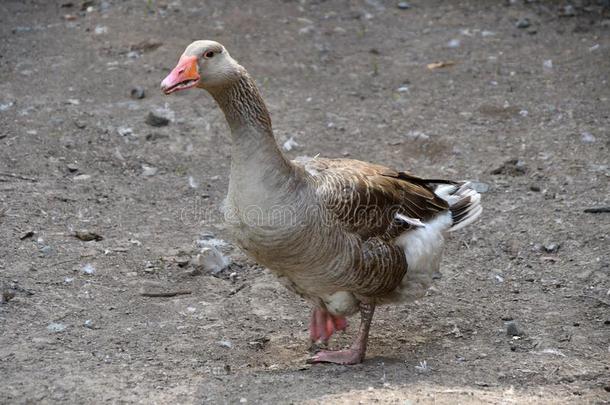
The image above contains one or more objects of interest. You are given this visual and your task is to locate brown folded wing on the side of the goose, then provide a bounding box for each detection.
[294,158,452,241]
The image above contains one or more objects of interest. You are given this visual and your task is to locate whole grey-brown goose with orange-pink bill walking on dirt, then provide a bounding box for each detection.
[161,40,482,364]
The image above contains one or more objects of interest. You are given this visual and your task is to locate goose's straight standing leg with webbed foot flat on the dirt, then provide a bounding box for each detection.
[307,304,375,364]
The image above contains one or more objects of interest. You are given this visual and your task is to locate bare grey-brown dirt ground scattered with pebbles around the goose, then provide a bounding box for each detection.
[0,0,610,404]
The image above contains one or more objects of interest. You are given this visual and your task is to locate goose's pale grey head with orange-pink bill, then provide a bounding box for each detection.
[161,41,243,94]
